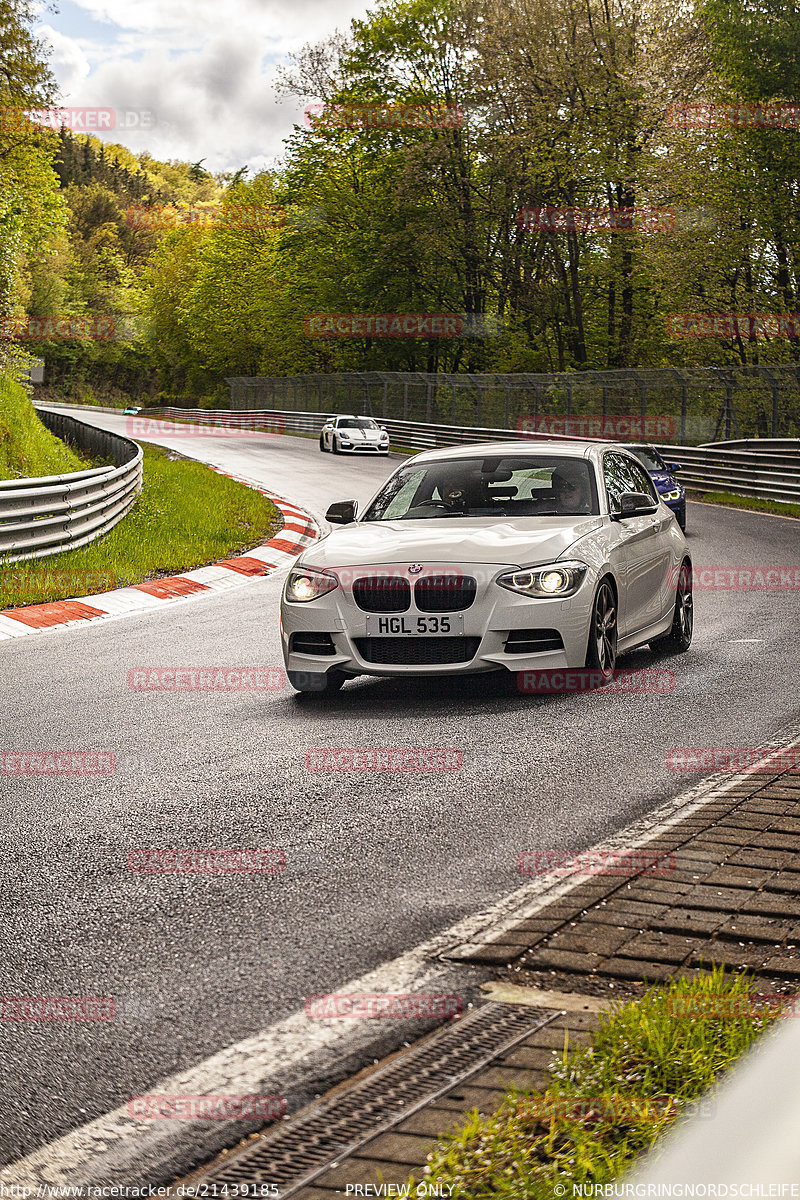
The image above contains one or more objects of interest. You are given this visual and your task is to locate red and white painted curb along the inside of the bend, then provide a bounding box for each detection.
[0,463,319,640]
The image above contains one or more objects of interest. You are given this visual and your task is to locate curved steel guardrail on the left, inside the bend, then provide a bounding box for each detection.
[0,409,142,563]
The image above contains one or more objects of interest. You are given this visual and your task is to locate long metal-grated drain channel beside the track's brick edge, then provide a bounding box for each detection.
[185,1002,560,1198]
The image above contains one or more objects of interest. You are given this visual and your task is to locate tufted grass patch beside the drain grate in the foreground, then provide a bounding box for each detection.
[409,968,776,1200]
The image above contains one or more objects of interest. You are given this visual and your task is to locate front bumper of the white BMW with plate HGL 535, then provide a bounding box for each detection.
[281,563,596,676]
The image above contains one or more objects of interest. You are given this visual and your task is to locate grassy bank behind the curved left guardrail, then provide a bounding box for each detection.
[0,374,94,479]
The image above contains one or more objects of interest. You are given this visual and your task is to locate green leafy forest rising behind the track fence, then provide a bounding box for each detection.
[0,0,800,402]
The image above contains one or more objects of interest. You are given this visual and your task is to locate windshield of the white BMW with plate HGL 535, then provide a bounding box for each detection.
[363,455,600,521]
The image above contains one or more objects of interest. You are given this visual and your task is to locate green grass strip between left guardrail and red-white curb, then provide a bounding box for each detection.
[0,445,283,608]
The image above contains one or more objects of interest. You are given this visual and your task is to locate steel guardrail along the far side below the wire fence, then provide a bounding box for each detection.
[143,408,800,504]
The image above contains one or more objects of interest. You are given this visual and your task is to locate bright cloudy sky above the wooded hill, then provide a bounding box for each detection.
[36,0,367,175]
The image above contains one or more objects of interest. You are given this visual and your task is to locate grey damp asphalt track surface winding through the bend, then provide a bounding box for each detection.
[0,414,800,1163]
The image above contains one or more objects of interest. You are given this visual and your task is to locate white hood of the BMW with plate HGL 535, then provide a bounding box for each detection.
[301,516,602,569]
